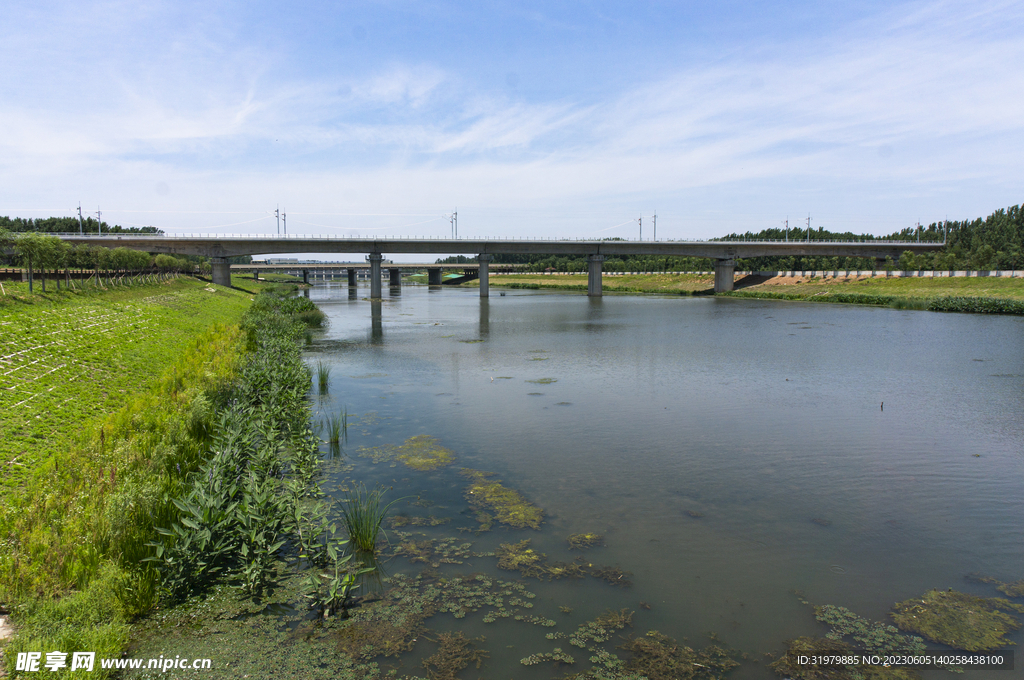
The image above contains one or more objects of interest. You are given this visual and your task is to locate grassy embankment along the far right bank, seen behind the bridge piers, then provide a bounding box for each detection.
[463,273,1024,314]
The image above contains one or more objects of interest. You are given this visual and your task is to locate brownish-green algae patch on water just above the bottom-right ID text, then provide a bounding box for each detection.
[892,589,1024,651]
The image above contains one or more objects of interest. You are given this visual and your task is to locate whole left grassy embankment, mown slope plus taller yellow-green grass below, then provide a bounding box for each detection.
[0,278,272,670]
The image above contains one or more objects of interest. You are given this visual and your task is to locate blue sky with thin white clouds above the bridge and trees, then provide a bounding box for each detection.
[0,0,1024,255]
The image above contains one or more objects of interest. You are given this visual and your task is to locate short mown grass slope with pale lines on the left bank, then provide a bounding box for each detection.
[0,279,256,487]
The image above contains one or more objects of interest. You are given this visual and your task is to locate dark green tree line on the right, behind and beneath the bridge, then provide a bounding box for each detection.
[437,205,1024,272]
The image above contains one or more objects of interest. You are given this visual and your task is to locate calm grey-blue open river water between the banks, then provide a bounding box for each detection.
[310,287,1024,678]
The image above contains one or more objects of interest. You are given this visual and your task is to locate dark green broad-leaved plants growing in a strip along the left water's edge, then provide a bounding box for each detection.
[148,294,366,615]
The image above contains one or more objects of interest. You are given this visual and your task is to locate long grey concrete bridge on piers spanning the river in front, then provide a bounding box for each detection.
[58,233,944,299]
